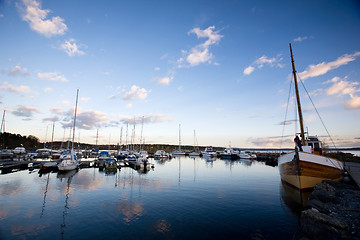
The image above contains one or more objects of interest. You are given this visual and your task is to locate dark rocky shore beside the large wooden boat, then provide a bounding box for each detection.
[294,181,360,240]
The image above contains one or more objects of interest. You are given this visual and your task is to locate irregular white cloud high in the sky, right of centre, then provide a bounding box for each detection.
[177,26,223,67]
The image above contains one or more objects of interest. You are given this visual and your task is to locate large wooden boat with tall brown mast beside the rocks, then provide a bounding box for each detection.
[278,44,344,191]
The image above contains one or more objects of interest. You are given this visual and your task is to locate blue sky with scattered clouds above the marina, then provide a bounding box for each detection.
[0,0,360,148]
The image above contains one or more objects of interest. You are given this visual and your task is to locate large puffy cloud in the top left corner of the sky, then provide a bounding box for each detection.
[22,0,67,37]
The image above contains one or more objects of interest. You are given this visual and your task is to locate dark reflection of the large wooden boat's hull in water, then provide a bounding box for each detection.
[280,182,311,216]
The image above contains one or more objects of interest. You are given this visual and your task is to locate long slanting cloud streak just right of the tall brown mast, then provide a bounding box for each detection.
[299,52,360,80]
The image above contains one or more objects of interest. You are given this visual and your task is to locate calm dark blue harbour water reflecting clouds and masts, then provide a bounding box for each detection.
[0,157,299,240]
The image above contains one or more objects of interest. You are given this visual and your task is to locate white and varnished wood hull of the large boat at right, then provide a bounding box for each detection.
[278,152,344,191]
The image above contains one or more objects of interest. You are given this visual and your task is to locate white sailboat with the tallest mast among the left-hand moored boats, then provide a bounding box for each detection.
[58,89,79,171]
